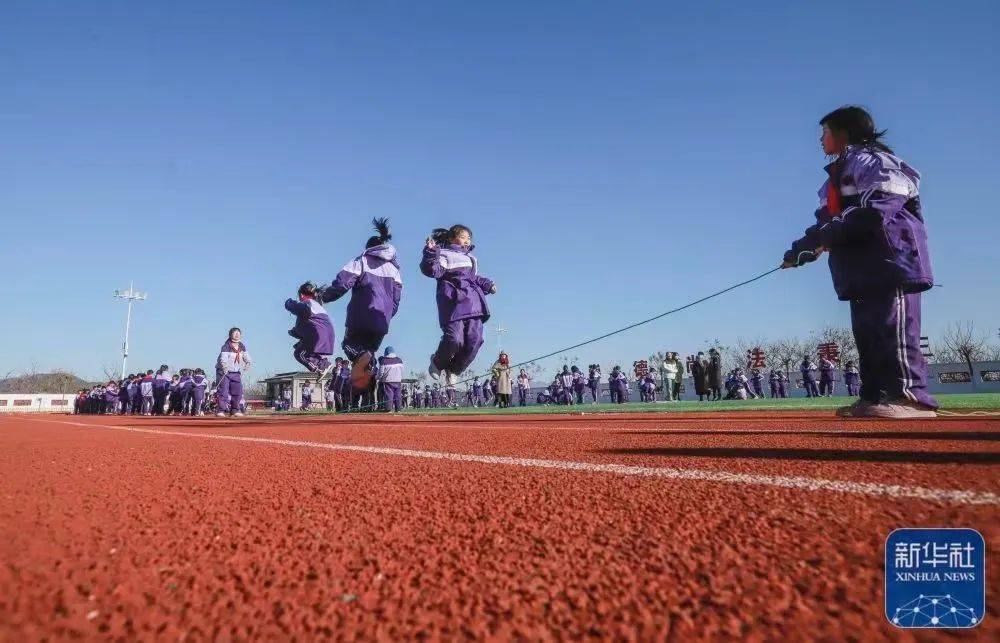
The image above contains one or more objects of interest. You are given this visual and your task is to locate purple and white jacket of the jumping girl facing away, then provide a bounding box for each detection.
[317,243,403,334]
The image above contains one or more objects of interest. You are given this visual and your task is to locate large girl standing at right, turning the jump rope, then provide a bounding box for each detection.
[781,106,938,418]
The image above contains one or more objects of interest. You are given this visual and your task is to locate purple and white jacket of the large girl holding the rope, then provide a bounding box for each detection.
[785,145,934,301]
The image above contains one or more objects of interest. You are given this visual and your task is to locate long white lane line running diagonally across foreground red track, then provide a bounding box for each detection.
[13,418,1000,505]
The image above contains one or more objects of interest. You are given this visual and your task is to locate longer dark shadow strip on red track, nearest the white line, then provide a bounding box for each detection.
[595,447,1000,464]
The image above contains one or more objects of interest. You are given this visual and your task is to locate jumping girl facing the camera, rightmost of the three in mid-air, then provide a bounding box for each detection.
[420,225,497,382]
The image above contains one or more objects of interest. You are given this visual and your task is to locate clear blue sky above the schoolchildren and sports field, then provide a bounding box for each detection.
[0,0,1000,377]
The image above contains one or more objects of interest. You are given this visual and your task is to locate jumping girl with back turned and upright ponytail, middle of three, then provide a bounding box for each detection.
[318,219,403,389]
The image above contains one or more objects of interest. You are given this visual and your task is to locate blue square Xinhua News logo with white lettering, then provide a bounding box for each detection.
[885,529,986,628]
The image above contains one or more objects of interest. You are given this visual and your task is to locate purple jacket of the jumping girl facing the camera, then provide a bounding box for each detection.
[420,243,493,328]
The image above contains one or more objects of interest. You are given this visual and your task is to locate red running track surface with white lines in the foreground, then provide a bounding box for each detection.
[0,413,1000,641]
